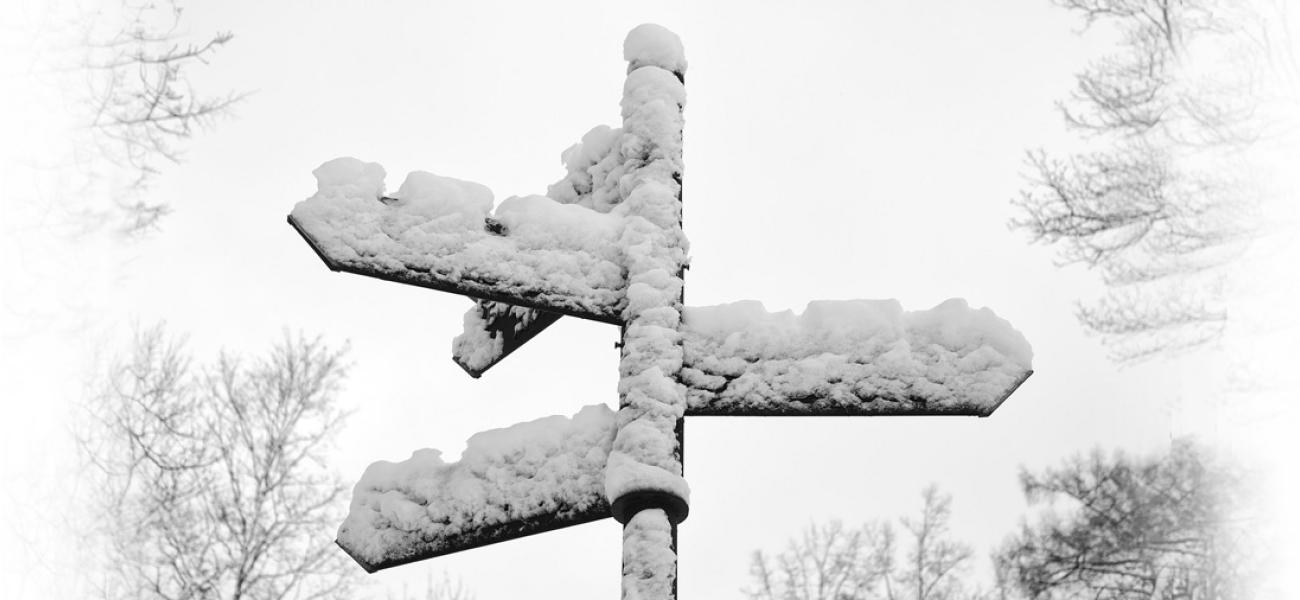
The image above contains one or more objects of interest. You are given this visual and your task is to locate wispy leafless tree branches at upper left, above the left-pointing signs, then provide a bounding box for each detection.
[35,0,244,235]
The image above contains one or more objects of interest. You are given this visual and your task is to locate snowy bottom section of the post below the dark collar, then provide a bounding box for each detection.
[623,508,677,600]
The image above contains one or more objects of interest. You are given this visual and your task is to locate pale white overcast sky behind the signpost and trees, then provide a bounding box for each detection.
[0,0,1294,600]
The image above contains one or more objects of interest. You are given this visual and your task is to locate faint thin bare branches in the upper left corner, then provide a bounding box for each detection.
[10,0,246,236]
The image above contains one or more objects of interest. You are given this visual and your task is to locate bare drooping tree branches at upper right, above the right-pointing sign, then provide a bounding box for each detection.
[1011,0,1300,361]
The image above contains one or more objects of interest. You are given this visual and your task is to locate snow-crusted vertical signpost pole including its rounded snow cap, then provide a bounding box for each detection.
[611,26,688,600]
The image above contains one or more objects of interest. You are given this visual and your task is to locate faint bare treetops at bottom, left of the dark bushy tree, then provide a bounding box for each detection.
[745,486,971,600]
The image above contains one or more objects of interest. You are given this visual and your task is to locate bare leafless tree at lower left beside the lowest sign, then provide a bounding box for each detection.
[79,327,359,600]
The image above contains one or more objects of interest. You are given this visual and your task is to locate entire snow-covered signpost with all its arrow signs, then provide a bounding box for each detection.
[289,25,1032,599]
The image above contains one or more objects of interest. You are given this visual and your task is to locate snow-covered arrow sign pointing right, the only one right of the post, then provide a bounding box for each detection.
[681,299,1032,416]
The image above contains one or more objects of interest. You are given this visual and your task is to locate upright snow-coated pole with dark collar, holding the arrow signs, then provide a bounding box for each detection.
[606,38,689,599]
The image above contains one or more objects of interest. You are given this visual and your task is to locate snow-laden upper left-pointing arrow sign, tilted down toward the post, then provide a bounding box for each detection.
[290,157,625,322]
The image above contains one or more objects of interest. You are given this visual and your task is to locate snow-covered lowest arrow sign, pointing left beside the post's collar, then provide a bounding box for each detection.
[338,404,615,571]
